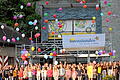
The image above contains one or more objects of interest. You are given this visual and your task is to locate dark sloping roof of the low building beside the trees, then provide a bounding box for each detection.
[0,23,30,44]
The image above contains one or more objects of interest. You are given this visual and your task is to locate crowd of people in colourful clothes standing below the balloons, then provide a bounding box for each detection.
[0,61,120,80]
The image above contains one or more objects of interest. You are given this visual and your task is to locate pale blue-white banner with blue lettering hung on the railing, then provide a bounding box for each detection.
[62,34,105,51]
